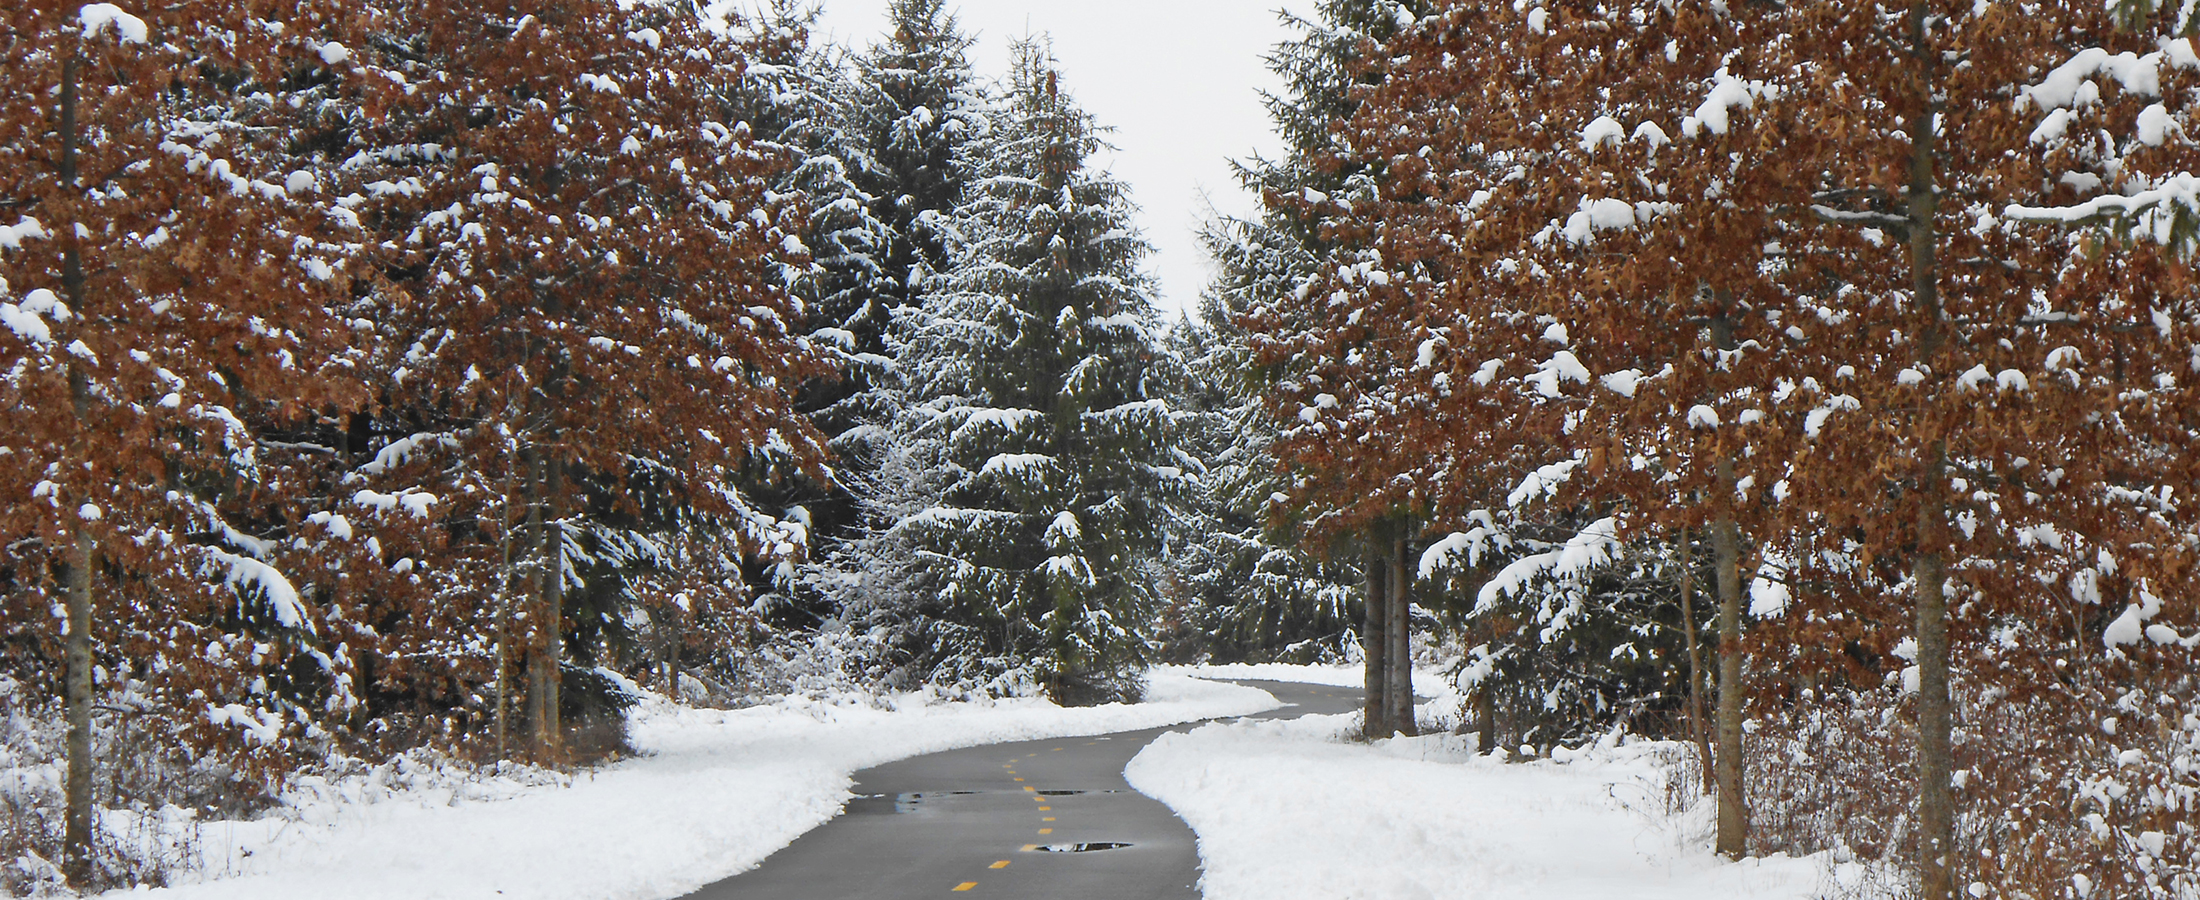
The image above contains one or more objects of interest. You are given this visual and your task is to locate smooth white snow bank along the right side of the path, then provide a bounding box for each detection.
[1126,715,1826,900]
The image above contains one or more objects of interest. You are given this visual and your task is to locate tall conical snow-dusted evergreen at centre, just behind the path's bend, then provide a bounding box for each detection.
[865,42,1186,704]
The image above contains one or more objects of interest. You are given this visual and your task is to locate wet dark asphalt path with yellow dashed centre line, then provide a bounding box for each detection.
[689,682,1360,900]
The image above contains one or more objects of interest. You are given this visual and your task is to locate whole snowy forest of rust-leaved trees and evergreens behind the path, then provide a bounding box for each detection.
[0,0,2200,900]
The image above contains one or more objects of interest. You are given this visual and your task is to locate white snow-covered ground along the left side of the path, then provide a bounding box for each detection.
[117,671,1276,900]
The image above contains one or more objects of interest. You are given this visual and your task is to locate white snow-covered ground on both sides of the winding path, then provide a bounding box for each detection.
[116,667,1828,900]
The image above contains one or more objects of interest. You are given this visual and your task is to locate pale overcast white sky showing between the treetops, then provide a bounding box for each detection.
[818,0,1311,317]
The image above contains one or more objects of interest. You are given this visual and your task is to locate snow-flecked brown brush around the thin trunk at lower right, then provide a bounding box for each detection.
[1745,658,2200,900]
